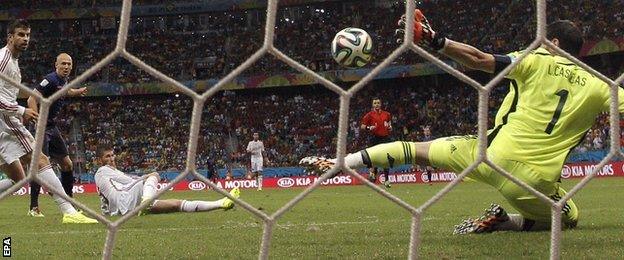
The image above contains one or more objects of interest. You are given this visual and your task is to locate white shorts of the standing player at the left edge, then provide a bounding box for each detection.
[0,115,35,165]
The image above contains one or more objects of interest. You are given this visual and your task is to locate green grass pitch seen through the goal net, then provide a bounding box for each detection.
[0,178,624,259]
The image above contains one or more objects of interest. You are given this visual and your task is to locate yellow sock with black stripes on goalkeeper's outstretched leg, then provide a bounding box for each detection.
[360,141,416,168]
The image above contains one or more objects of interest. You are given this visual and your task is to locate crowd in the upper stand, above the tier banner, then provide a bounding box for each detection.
[2,0,624,84]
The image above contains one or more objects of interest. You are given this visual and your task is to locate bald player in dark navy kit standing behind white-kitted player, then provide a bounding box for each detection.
[28,53,87,217]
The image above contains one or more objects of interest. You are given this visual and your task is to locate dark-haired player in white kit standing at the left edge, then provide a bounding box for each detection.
[0,19,97,223]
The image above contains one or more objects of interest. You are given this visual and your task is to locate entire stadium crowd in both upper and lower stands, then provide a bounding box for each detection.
[0,0,624,176]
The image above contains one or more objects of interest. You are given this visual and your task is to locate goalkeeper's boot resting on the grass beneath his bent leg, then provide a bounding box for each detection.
[453,203,509,235]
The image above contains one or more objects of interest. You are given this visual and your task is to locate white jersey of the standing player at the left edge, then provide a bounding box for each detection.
[0,46,25,117]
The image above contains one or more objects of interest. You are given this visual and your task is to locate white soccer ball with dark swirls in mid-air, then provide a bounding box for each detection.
[332,27,373,68]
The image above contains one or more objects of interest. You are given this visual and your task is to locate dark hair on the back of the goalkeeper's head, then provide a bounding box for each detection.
[546,20,583,56]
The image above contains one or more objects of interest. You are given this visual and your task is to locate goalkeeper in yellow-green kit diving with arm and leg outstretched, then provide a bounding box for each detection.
[301,10,624,234]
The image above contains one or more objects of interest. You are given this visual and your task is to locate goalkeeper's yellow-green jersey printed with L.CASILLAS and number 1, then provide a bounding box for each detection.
[488,48,624,181]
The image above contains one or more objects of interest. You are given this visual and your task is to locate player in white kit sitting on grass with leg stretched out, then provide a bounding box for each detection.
[95,144,240,215]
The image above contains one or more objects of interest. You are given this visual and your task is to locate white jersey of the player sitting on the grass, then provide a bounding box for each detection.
[95,165,144,215]
